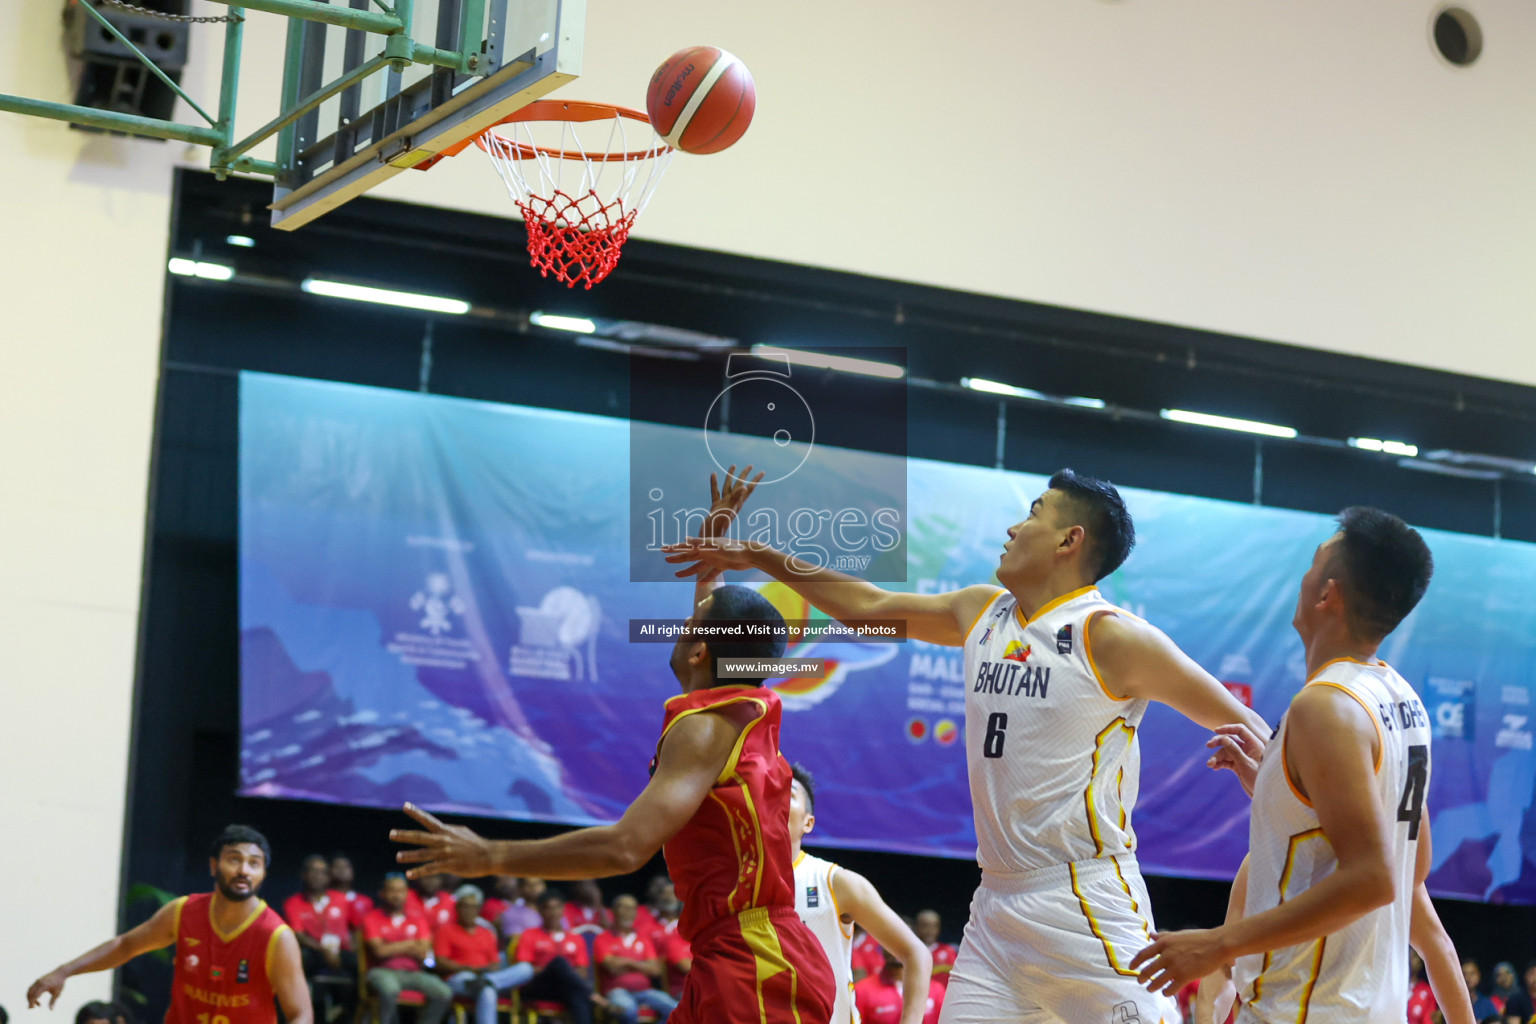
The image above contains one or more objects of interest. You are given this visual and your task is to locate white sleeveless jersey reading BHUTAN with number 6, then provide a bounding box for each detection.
[965,586,1147,877]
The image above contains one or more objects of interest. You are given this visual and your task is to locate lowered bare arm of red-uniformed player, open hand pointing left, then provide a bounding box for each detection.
[389,712,743,881]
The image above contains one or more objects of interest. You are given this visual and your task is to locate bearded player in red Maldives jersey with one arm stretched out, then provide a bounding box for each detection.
[26,824,315,1024]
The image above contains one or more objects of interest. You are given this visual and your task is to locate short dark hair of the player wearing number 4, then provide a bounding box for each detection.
[1332,505,1435,642]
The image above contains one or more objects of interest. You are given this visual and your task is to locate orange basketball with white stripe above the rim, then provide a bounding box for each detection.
[645,46,757,154]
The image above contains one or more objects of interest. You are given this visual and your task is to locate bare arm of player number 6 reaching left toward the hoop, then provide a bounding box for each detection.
[662,539,1001,646]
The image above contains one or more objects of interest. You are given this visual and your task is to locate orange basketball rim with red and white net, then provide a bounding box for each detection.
[422,100,674,289]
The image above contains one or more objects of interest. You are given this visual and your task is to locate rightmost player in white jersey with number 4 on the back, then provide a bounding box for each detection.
[1134,508,1473,1024]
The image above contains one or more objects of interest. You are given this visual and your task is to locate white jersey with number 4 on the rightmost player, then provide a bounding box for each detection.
[1235,659,1430,1024]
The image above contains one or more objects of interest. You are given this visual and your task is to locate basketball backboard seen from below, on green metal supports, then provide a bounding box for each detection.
[272,0,587,230]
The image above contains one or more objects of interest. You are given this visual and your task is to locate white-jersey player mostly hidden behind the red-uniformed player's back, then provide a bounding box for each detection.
[790,765,934,1024]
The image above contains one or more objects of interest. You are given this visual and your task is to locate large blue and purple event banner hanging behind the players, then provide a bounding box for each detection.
[240,373,1536,904]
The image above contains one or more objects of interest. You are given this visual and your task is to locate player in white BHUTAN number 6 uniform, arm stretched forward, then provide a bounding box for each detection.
[665,470,1269,1024]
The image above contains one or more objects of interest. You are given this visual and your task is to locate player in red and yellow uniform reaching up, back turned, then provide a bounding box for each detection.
[390,467,834,1024]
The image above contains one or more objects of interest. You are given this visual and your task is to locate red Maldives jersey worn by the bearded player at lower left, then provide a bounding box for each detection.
[166,892,292,1024]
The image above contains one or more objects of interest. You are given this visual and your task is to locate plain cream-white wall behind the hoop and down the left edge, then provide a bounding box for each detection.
[0,0,1536,1013]
